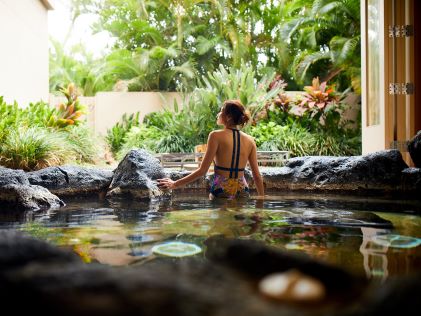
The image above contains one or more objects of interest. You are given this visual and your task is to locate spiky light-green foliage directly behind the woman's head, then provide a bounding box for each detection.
[115,65,281,157]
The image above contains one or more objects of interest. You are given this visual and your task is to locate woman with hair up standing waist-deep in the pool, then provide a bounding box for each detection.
[158,100,264,199]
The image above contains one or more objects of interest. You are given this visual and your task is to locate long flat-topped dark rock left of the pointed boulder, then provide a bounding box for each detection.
[27,166,113,196]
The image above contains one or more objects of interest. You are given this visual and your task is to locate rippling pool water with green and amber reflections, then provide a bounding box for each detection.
[0,193,421,279]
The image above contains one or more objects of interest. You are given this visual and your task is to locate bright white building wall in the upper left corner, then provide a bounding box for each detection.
[0,0,48,107]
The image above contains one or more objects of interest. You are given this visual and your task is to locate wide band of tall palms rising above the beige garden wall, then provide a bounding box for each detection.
[63,0,360,95]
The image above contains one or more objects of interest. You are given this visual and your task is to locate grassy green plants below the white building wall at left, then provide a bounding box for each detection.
[0,93,98,170]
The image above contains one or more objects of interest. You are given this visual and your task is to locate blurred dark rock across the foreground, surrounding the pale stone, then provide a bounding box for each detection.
[0,232,421,316]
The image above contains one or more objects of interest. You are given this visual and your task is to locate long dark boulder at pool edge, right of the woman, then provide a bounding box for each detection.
[264,150,408,192]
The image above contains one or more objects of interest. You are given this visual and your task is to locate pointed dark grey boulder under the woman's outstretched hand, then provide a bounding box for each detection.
[107,149,167,199]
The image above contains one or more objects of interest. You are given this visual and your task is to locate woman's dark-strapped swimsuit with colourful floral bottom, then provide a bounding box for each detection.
[210,129,249,199]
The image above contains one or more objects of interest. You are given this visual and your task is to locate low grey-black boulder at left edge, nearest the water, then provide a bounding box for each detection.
[0,184,65,211]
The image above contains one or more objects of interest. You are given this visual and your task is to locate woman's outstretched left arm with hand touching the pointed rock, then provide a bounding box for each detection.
[158,132,218,189]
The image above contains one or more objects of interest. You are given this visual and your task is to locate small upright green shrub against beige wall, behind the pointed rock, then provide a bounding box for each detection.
[105,112,140,155]
